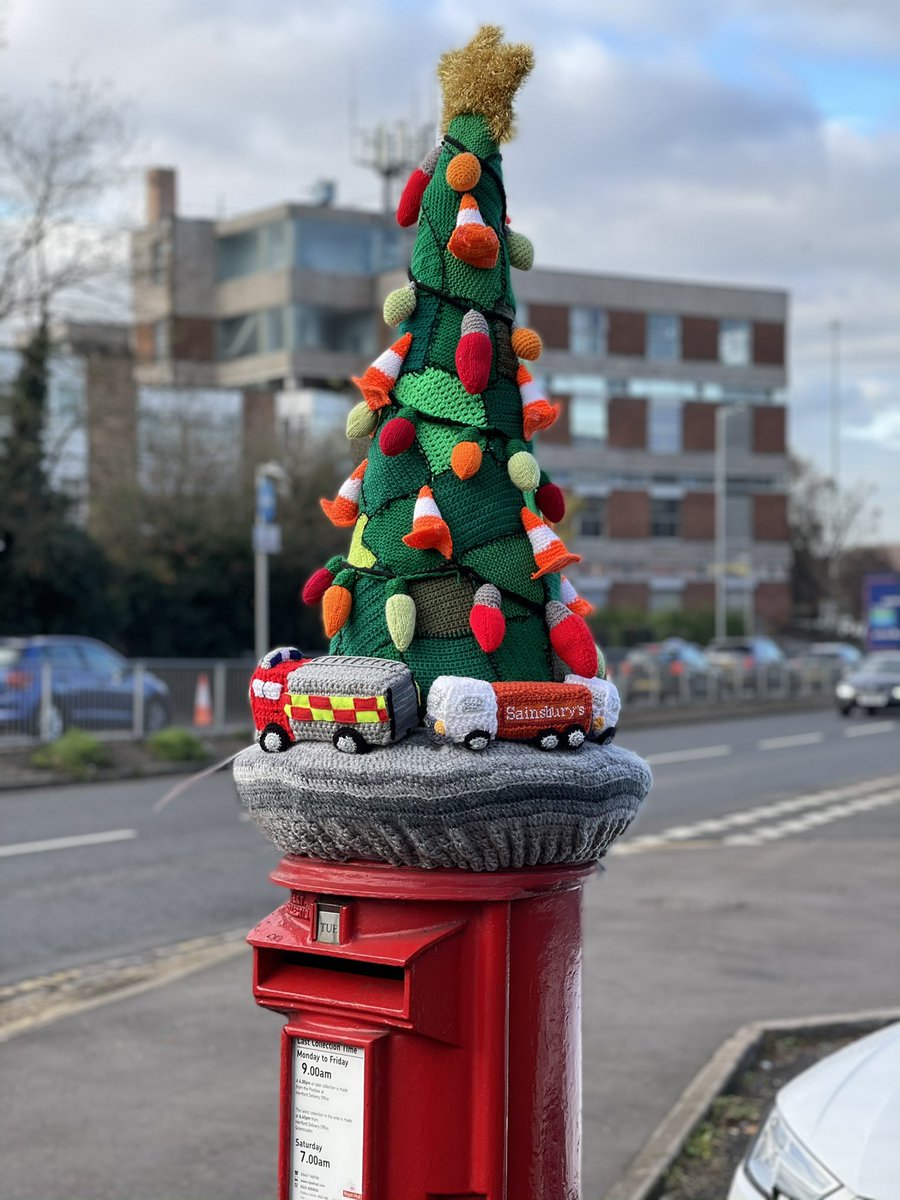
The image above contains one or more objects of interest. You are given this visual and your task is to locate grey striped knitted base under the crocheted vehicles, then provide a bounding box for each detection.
[234,730,650,871]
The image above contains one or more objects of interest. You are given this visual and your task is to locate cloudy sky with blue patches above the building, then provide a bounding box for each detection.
[0,0,900,541]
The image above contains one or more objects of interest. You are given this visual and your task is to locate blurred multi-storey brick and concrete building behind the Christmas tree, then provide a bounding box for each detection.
[133,169,790,628]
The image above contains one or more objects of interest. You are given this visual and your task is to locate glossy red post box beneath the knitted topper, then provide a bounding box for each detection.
[248,856,594,1200]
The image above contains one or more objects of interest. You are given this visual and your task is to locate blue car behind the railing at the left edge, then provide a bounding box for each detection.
[0,636,172,742]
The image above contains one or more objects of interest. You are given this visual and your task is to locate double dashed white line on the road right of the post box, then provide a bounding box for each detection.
[611,775,900,854]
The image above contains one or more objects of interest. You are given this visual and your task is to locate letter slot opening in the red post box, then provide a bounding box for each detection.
[257,947,407,1016]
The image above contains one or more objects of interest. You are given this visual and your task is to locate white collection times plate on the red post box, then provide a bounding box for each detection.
[290,1038,366,1200]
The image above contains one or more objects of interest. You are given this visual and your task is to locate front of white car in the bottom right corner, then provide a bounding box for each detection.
[728,1022,900,1200]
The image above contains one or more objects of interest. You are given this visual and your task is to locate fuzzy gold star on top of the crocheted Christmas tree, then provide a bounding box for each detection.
[438,25,534,143]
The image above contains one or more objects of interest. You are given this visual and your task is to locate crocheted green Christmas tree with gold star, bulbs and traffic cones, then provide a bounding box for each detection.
[304,26,601,694]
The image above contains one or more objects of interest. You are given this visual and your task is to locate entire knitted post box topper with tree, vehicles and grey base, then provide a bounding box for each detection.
[235,26,649,870]
